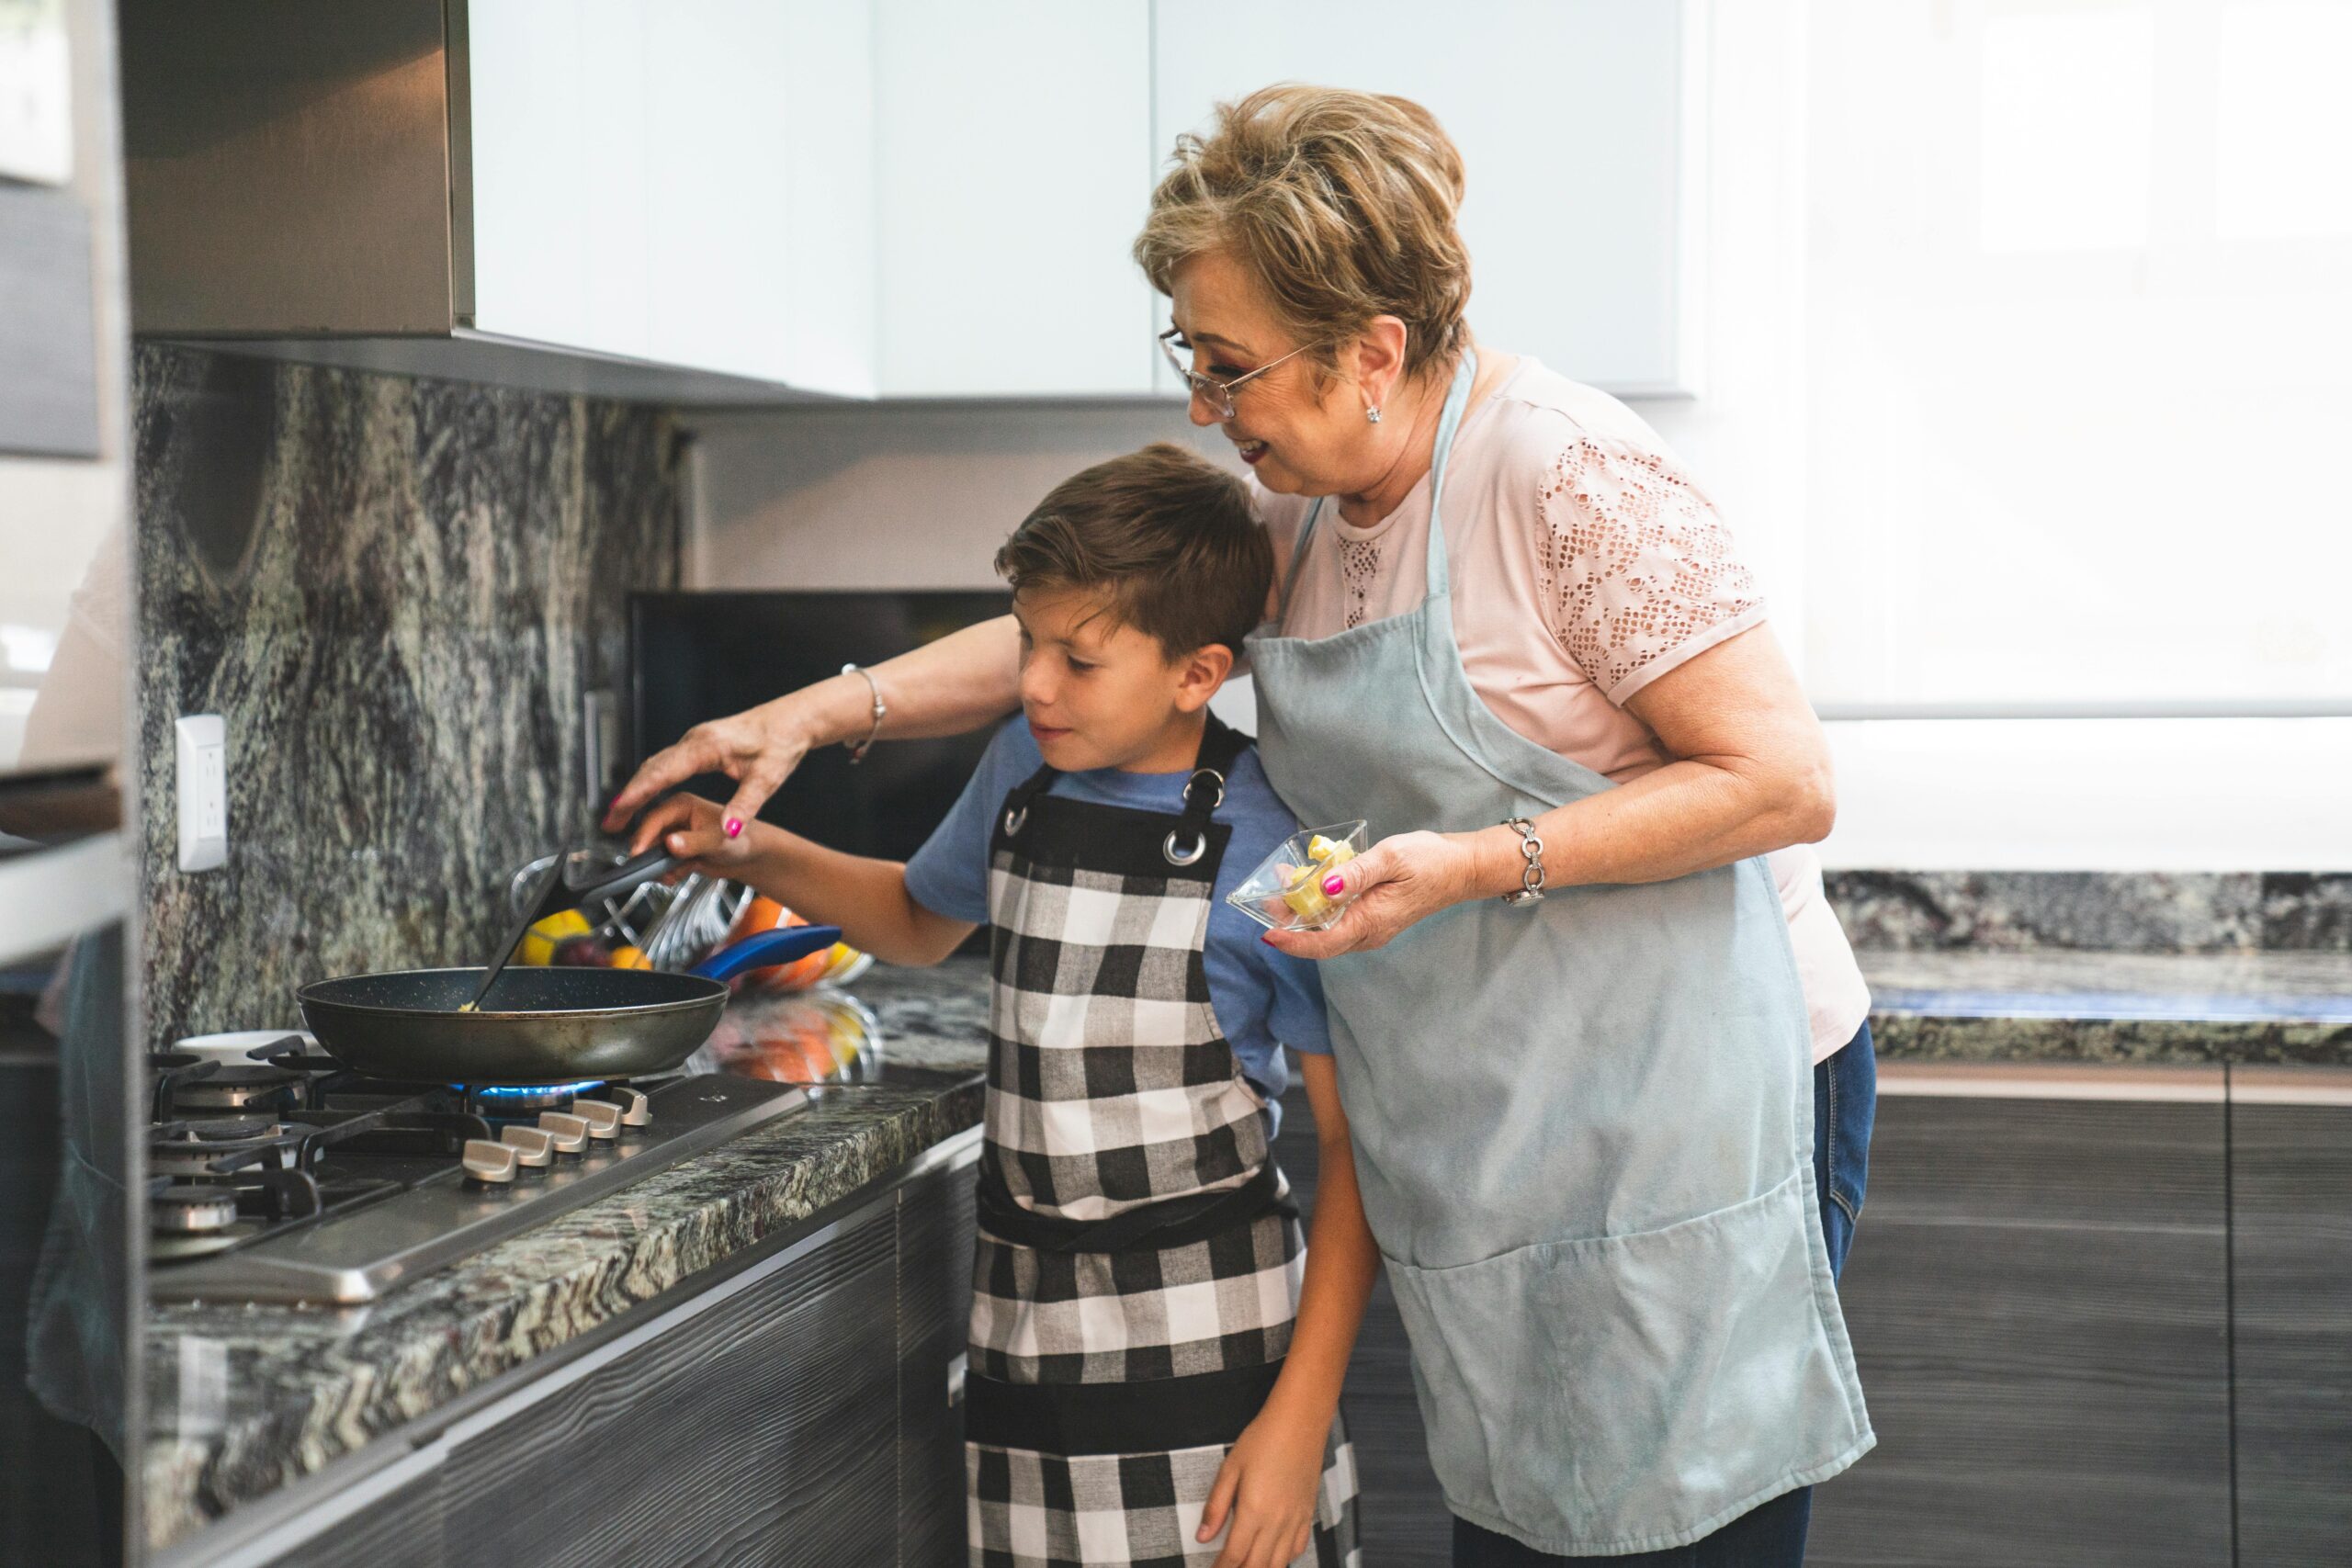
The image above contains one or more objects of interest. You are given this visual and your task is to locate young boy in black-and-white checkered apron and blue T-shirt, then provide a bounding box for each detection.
[638,445,1378,1568]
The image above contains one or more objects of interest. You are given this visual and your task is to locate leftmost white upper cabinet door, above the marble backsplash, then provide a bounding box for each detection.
[466,0,875,395]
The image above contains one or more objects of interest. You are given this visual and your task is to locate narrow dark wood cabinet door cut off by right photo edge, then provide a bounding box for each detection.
[2230,1067,2352,1568]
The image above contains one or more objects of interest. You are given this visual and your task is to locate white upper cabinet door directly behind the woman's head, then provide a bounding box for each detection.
[1152,0,1698,392]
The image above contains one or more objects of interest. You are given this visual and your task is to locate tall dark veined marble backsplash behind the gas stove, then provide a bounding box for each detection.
[131,345,680,1042]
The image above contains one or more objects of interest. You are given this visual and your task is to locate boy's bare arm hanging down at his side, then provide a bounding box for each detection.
[1200,1055,1381,1568]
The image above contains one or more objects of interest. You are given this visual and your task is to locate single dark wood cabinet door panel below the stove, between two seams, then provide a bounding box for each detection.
[442,1208,899,1568]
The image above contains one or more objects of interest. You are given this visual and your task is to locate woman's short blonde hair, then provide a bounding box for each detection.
[1136,83,1470,374]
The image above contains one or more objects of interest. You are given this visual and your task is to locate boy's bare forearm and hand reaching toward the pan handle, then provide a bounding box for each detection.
[633,795,974,964]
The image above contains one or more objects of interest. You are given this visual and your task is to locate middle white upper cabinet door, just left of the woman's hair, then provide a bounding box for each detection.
[875,0,1159,398]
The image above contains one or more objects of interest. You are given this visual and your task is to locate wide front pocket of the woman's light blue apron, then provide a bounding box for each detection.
[1387,1173,1868,1554]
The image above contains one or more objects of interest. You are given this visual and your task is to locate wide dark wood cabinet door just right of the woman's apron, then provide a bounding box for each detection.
[1809,1093,2230,1568]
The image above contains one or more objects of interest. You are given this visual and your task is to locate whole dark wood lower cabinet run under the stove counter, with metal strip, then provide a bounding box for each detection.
[224,1143,976,1568]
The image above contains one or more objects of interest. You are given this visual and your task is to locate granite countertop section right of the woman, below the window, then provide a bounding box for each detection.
[1856,950,2352,1065]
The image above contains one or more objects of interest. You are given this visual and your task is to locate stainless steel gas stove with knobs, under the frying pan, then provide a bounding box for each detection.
[148,1034,809,1304]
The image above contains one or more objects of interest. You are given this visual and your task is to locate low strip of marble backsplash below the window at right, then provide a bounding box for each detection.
[1827,870,2352,952]
